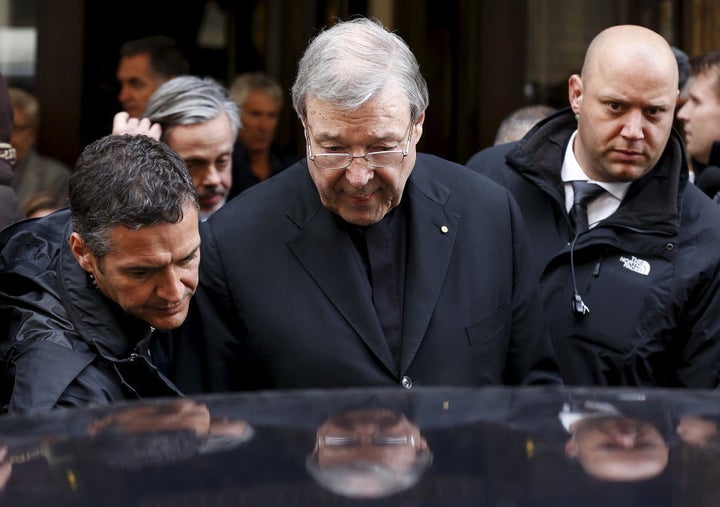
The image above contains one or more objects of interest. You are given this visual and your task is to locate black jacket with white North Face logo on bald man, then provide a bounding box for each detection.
[467,109,720,388]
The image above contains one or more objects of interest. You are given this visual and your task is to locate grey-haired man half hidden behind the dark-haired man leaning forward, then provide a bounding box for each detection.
[119,76,240,220]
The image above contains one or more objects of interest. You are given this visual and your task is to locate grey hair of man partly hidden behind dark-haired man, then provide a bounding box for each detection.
[143,76,240,140]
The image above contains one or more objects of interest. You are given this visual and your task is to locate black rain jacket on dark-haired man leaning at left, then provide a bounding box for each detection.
[0,208,180,413]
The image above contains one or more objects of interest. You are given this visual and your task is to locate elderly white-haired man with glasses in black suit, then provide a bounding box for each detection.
[174,18,559,392]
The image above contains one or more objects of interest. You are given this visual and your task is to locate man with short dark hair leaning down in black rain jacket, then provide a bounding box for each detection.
[0,135,200,412]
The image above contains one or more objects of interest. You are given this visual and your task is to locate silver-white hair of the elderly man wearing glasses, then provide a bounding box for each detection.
[292,18,430,121]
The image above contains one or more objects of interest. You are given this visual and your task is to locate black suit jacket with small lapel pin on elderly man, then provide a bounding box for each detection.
[175,154,557,392]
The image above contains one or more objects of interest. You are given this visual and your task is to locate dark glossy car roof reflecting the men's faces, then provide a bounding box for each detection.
[0,387,720,507]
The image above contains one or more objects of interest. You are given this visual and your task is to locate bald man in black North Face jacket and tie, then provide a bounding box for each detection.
[467,25,720,388]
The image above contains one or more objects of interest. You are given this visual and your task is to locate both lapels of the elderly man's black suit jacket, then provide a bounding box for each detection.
[287,161,460,374]
